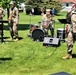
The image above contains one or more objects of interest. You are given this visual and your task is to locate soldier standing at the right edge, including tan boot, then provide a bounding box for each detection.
[63,10,76,59]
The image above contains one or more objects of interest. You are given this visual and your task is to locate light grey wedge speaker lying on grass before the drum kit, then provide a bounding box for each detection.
[43,37,60,46]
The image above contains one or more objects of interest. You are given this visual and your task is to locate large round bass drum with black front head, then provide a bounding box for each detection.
[32,29,44,41]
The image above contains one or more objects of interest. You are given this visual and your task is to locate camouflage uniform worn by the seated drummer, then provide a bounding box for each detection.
[42,10,54,37]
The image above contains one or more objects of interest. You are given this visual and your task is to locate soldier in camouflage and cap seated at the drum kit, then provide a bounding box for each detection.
[42,9,54,37]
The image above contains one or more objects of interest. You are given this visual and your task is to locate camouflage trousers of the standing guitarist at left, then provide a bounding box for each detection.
[9,22,18,38]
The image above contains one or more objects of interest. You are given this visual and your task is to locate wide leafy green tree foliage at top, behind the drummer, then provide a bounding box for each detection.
[24,0,61,13]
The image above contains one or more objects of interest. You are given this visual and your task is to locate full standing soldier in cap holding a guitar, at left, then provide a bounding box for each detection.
[9,1,19,41]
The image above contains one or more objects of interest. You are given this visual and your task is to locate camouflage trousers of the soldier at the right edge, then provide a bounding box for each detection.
[67,32,76,54]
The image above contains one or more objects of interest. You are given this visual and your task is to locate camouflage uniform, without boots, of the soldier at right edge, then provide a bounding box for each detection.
[67,13,76,54]
